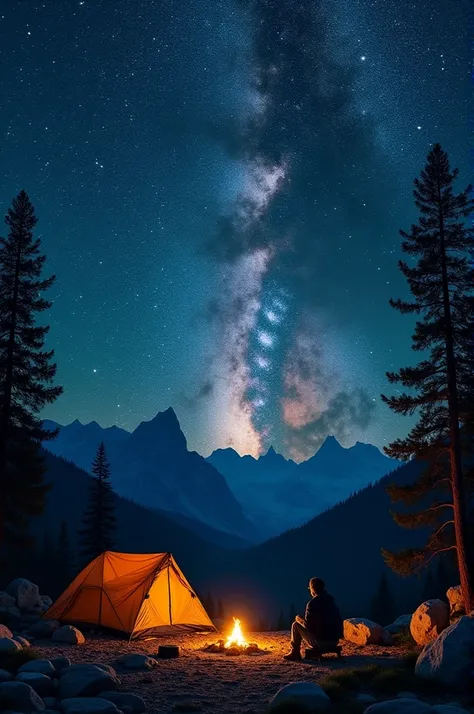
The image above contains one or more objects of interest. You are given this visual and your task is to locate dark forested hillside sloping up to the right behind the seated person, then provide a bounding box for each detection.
[207,463,426,618]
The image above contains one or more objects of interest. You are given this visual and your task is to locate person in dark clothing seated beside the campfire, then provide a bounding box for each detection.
[285,578,343,662]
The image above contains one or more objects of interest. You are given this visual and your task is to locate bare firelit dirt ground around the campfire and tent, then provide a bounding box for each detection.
[34,632,410,714]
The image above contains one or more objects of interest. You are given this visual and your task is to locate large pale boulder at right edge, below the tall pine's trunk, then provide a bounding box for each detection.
[415,615,474,687]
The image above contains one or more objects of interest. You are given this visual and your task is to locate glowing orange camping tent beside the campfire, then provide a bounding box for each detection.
[43,551,216,639]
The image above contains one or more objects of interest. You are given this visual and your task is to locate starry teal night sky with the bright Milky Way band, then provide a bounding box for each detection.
[0,0,472,460]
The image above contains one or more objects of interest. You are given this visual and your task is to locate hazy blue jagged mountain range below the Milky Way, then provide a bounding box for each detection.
[44,408,398,536]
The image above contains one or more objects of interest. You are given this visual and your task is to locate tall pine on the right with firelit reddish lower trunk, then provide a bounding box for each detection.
[382,144,474,611]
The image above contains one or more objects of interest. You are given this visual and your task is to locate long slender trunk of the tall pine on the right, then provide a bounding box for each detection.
[438,170,474,614]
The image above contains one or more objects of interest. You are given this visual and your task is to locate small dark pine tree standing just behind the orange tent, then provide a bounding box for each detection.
[79,442,116,562]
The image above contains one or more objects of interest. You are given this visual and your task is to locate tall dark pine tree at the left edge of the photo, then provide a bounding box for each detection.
[0,191,62,547]
